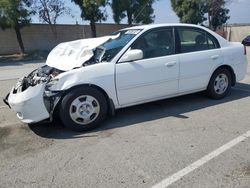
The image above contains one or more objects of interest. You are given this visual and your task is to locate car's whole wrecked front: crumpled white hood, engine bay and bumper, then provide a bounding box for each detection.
[4,35,119,123]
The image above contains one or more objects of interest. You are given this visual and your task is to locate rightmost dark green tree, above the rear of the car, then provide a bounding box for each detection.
[203,0,230,30]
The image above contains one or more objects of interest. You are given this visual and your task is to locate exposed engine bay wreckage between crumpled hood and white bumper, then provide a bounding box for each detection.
[13,65,64,93]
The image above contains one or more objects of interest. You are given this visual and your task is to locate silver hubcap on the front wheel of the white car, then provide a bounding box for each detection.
[69,95,100,125]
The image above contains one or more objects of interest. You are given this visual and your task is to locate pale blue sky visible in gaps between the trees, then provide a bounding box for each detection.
[32,0,250,24]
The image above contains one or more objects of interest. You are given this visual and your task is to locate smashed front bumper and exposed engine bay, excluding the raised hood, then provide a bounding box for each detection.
[4,65,63,123]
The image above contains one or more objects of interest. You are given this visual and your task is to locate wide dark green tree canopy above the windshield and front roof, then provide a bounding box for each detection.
[111,0,155,25]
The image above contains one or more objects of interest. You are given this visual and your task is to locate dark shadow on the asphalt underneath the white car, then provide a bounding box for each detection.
[29,83,250,139]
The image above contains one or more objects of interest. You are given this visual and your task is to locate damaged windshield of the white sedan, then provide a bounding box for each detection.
[94,29,141,62]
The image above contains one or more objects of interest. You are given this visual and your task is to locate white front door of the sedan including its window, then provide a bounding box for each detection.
[116,27,179,106]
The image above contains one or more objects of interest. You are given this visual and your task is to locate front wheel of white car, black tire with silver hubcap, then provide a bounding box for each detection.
[59,87,108,131]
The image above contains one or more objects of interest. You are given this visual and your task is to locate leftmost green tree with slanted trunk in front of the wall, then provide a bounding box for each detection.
[0,0,34,54]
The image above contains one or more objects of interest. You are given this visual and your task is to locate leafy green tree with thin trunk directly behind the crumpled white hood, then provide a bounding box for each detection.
[72,0,108,37]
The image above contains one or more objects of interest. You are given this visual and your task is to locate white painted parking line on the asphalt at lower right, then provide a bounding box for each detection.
[152,131,250,188]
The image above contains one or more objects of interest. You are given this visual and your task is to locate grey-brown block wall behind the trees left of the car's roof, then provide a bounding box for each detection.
[0,24,131,54]
